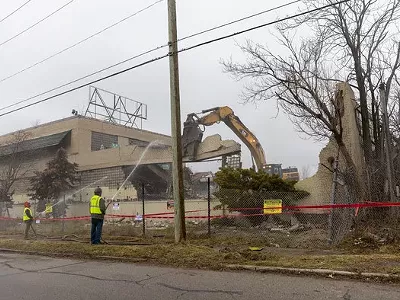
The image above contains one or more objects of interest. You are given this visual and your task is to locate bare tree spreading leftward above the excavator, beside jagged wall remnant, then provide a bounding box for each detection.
[224,36,354,173]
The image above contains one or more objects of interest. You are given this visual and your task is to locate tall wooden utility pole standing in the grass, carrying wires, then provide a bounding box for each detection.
[168,0,186,243]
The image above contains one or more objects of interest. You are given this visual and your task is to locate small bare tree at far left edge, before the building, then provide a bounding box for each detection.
[0,131,30,216]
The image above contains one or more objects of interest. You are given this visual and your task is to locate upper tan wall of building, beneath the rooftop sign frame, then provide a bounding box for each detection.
[0,116,171,170]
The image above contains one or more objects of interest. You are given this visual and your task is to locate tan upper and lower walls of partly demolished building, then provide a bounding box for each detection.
[0,116,171,203]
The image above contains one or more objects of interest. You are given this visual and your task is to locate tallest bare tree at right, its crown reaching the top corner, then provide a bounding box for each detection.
[290,0,400,162]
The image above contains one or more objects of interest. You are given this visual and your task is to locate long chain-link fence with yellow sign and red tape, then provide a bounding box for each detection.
[0,175,400,248]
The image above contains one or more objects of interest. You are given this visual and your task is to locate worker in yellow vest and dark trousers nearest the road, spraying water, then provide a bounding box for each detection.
[89,187,107,245]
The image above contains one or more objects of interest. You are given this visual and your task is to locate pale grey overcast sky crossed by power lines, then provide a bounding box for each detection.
[0,0,323,176]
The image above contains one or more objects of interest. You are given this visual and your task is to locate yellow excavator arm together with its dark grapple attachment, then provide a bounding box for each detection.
[182,106,267,170]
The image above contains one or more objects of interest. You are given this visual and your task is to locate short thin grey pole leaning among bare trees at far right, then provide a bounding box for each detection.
[379,83,396,202]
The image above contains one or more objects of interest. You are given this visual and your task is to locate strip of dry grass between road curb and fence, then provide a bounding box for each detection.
[0,238,400,274]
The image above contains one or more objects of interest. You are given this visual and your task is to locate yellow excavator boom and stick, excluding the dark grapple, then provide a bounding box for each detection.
[184,106,267,170]
